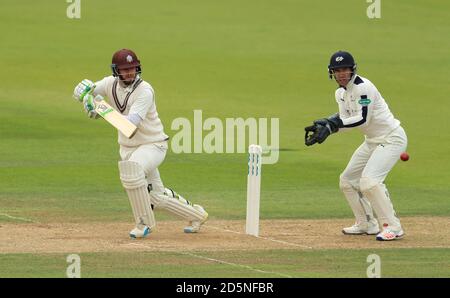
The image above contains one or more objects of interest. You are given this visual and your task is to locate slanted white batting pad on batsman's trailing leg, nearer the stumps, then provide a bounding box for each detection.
[150,190,207,221]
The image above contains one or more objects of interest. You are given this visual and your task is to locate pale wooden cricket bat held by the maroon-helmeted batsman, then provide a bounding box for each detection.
[94,95,137,139]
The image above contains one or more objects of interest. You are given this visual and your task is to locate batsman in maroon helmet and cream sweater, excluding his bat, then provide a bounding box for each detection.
[74,49,208,238]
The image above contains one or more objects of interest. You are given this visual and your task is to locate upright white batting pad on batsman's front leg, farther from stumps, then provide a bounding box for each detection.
[119,161,156,229]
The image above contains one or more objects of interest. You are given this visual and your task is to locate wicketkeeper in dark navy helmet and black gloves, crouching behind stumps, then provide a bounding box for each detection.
[305,51,407,240]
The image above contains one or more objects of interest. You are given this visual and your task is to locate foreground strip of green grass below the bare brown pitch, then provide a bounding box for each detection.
[0,249,450,278]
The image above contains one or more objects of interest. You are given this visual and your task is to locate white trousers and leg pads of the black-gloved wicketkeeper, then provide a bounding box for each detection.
[340,126,408,228]
